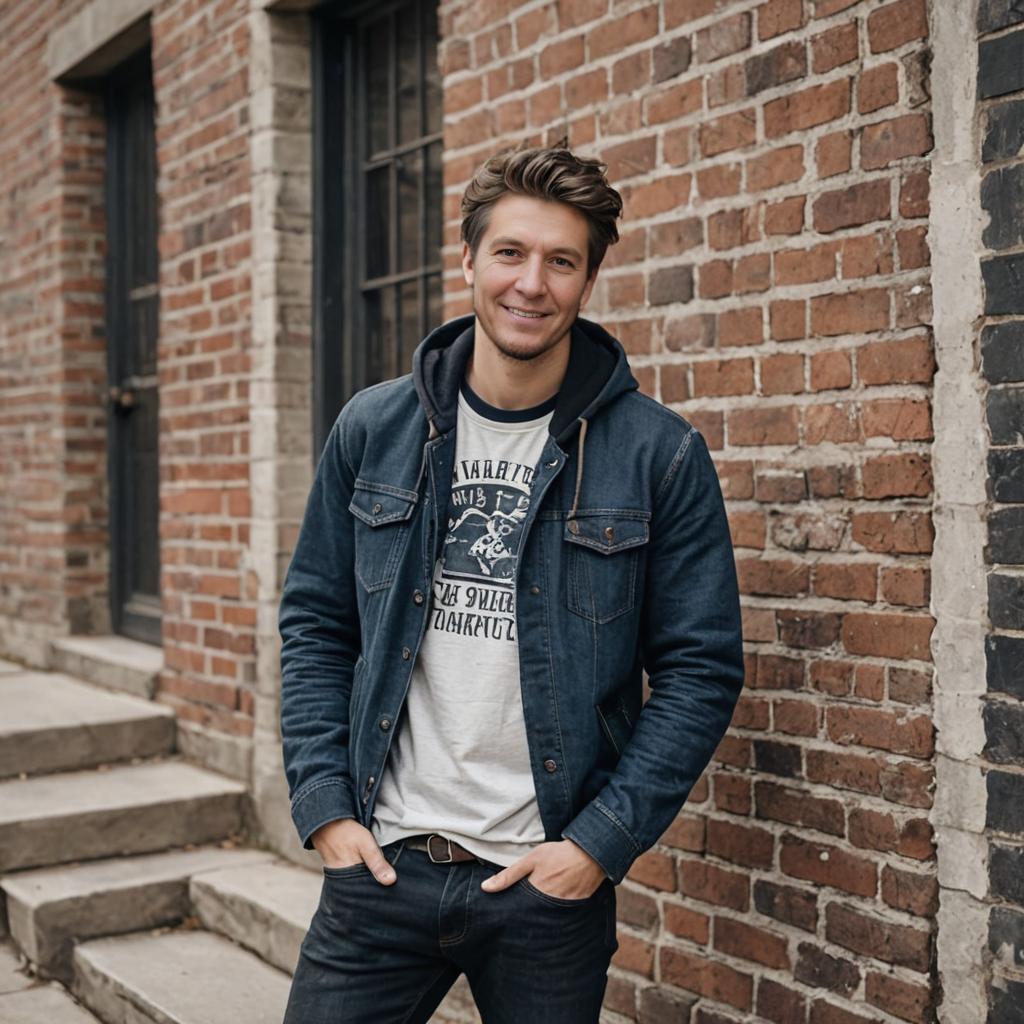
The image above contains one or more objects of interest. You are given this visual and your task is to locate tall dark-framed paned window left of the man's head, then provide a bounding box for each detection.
[313,0,442,454]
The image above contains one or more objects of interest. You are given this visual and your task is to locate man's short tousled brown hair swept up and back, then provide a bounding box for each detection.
[462,144,623,274]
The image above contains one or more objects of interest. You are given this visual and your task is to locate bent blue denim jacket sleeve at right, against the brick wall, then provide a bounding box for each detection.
[562,428,743,883]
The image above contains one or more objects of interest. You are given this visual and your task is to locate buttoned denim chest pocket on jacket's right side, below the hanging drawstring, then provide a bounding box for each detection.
[562,509,650,624]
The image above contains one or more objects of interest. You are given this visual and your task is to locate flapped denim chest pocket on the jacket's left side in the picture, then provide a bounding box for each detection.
[348,479,419,591]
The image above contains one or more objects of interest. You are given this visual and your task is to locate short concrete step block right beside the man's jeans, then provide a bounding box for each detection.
[189,860,324,974]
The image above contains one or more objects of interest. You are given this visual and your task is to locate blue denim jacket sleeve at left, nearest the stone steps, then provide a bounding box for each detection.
[278,407,360,849]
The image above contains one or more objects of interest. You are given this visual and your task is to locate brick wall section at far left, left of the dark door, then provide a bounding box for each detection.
[0,4,109,664]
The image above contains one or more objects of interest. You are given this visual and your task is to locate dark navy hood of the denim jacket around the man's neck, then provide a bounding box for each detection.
[413,314,639,444]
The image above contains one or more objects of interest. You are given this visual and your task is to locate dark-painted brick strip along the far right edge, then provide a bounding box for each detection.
[978,0,1024,1024]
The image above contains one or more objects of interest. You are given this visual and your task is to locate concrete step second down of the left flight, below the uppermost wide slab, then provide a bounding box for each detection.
[0,761,247,872]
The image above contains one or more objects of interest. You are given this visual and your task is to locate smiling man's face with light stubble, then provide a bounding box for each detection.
[462,195,597,360]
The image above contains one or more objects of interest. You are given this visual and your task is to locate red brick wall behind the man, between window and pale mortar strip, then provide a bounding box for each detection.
[441,0,937,1024]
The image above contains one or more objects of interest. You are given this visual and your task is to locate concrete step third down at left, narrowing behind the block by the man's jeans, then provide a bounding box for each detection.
[0,847,272,978]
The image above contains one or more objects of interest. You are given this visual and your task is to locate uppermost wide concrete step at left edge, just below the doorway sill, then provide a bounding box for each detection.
[0,672,174,778]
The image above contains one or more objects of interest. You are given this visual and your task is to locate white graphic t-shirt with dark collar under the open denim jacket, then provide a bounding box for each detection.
[372,384,555,866]
